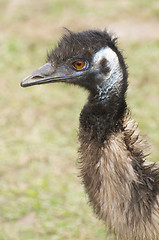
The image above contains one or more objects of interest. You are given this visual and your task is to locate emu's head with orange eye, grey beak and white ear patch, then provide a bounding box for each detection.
[21,30,127,101]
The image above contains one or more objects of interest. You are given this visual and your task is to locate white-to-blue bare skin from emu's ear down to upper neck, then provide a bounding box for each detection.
[92,47,123,101]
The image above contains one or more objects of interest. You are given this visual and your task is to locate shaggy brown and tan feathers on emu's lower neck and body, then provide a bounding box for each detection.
[79,114,159,240]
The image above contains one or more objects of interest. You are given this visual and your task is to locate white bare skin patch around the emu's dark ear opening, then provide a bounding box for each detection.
[92,46,123,99]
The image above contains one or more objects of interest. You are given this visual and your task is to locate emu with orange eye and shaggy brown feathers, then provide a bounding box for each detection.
[21,30,159,240]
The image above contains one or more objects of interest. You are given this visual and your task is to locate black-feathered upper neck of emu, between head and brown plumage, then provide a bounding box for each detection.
[80,94,126,145]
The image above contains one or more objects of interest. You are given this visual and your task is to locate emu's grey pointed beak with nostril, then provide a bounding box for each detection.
[21,63,75,87]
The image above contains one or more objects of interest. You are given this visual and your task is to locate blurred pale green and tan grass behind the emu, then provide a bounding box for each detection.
[0,0,159,240]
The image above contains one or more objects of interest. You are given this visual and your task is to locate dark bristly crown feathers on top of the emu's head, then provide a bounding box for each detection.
[48,30,117,64]
